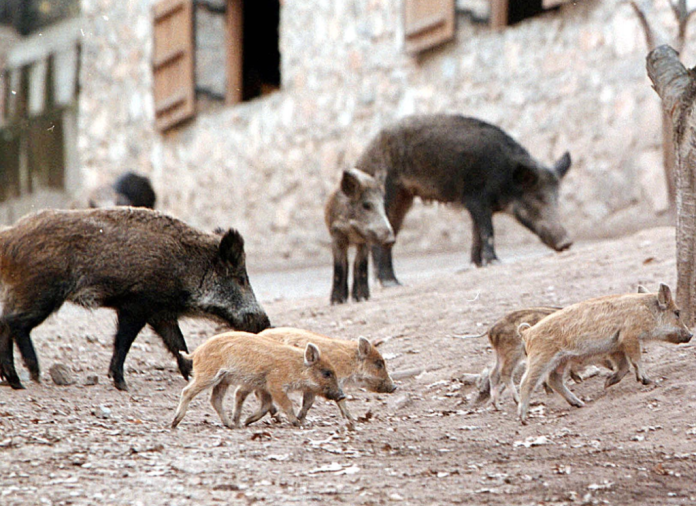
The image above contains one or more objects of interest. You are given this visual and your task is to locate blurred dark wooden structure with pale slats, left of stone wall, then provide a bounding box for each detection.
[0,9,80,203]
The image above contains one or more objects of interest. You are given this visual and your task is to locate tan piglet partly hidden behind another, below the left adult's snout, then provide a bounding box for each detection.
[258,327,396,427]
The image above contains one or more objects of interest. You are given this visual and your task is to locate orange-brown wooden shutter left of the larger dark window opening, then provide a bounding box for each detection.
[152,0,196,131]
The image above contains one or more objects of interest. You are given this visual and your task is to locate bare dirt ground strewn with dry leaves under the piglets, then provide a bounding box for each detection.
[0,228,696,506]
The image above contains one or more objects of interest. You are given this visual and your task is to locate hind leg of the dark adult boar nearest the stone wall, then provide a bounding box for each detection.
[372,180,413,287]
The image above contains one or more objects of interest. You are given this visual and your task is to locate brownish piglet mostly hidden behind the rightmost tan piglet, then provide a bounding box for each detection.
[477,306,561,409]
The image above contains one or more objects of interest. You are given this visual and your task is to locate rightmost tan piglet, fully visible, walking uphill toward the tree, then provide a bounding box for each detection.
[518,284,692,423]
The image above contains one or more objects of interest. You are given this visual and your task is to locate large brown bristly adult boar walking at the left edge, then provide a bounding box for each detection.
[0,207,270,390]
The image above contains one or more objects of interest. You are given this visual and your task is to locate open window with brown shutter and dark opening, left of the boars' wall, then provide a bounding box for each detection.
[152,0,281,131]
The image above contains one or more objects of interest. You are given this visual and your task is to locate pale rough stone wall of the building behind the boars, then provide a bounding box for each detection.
[79,0,694,261]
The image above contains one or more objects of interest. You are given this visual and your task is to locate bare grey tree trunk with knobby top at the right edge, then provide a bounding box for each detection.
[647,46,696,326]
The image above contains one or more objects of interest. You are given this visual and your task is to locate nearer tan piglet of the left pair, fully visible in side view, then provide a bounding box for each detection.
[172,332,345,428]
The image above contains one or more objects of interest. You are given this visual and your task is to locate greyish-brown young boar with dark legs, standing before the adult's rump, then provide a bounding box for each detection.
[324,169,394,304]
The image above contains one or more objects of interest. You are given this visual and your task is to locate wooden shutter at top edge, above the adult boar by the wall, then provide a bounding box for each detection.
[404,0,454,54]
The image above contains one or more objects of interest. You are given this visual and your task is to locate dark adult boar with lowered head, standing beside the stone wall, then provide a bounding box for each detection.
[356,114,572,286]
